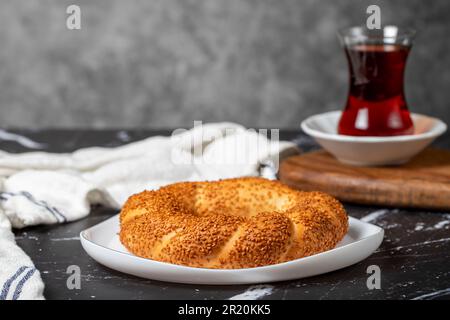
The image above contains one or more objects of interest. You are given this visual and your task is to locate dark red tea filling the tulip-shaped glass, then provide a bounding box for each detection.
[338,44,414,136]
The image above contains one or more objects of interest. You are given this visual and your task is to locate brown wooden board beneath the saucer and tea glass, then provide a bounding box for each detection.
[279,148,450,210]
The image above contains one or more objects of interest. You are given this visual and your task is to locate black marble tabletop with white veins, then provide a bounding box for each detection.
[0,130,450,299]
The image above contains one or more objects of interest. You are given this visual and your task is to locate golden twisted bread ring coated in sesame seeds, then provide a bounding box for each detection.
[120,178,348,269]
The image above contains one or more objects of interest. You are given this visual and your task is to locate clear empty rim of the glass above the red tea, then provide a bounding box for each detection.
[337,25,417,40]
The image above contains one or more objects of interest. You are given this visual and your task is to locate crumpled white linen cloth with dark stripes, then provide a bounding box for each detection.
[0,123,297,300]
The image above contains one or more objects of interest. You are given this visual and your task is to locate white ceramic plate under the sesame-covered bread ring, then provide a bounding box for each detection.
[80,215,384,285]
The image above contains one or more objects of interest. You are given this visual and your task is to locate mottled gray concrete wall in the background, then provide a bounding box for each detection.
[0,0,450,128]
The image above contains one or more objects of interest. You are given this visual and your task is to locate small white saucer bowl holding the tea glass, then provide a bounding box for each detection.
[301,111,447,166]
